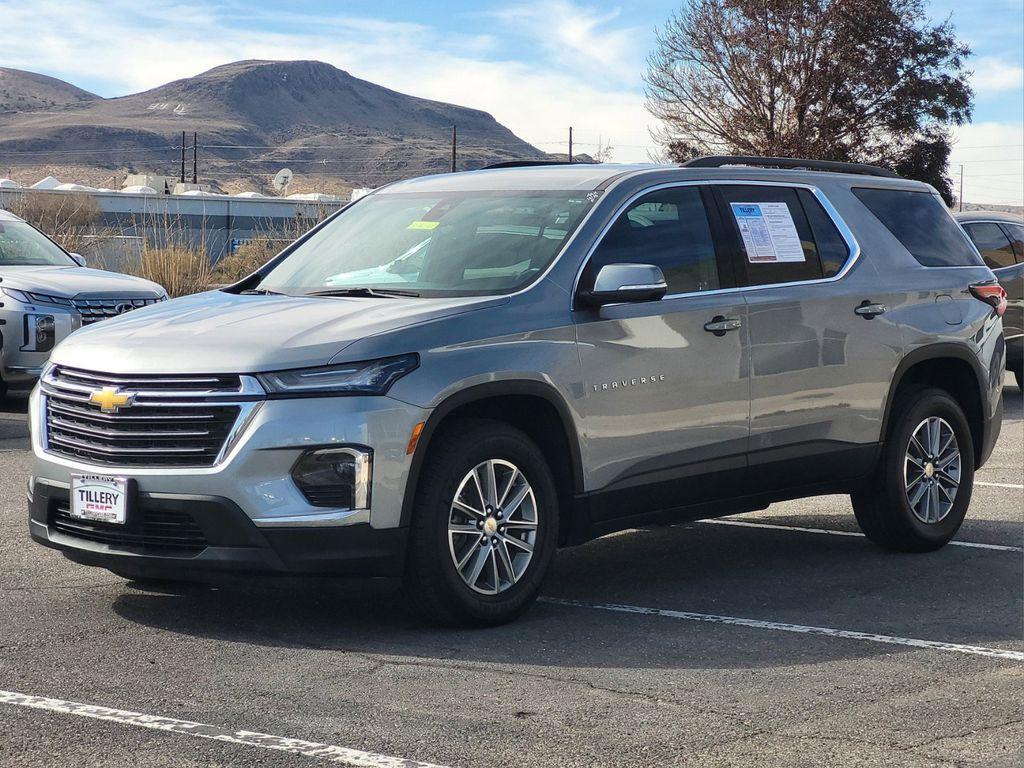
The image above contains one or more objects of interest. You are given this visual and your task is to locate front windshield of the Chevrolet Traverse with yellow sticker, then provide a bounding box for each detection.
[255,191,597,296]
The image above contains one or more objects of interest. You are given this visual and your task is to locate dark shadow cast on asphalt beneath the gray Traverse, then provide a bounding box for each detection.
[113,514,1022,669]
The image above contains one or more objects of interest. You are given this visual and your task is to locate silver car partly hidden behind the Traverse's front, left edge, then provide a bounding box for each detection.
[0,211,167,396]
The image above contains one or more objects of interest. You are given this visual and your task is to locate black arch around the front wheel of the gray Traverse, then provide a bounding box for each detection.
[400,380,584,541]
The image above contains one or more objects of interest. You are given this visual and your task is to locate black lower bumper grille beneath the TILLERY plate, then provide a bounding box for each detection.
[50,506,207,553]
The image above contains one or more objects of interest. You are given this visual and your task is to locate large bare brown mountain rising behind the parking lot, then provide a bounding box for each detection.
[0,60,546,184]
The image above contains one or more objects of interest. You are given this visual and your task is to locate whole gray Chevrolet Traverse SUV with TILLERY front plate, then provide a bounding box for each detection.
[29,158,1006,625]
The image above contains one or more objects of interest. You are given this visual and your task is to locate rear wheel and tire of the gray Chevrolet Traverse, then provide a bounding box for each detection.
[852,387,974,552]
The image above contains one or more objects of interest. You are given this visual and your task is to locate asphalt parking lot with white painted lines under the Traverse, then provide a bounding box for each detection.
[0,379,1024,767]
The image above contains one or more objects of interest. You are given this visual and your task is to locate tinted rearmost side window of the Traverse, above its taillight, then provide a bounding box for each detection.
[853,187,984,266]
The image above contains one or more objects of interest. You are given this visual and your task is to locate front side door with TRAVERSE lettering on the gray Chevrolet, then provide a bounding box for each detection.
[574,185,750,522]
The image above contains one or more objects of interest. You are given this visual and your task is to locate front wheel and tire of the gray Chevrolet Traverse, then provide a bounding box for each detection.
[404,419,558,627]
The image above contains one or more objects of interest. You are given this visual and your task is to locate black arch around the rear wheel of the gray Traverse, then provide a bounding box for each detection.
[882,343,987,467]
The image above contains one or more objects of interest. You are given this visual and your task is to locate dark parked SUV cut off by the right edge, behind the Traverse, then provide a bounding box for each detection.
[956,211,1024,389]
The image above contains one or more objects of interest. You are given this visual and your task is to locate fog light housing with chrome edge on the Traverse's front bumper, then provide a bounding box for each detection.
[292,446,373,509]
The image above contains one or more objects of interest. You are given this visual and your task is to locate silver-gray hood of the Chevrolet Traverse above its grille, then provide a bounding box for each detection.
[51,291,508,374]
